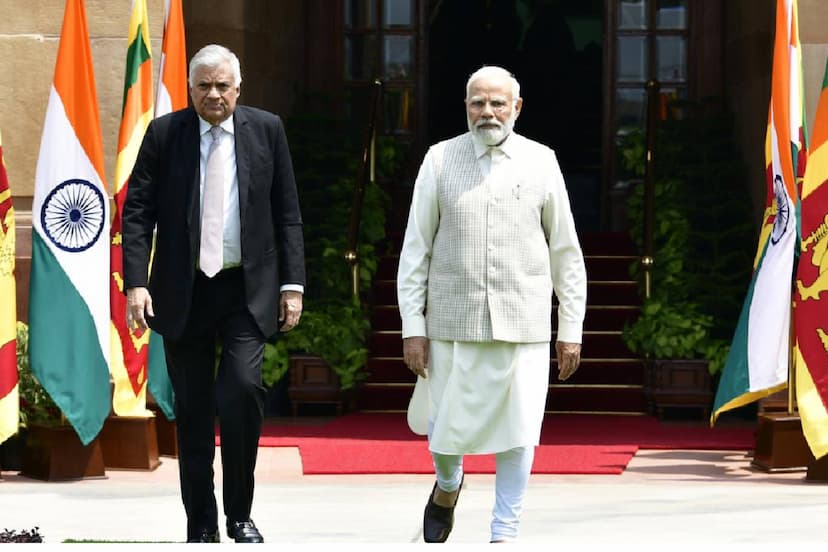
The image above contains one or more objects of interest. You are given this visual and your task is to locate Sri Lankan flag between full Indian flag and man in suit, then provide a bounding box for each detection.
[109,0,153,416]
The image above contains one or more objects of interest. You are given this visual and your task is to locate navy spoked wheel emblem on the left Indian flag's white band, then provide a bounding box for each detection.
[40,179,106,252]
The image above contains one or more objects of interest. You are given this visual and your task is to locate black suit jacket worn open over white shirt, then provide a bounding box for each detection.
[122,106,305,339]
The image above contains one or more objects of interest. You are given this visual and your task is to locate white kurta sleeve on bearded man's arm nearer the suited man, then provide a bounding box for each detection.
[397,148,440,338]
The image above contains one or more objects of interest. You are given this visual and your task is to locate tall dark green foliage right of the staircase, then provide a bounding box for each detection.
[621,101,755,373]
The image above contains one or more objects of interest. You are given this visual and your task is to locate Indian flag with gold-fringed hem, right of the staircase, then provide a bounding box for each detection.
[710,0,805,425]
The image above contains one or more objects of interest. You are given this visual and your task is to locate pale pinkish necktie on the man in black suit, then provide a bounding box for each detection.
[199,126,224,278]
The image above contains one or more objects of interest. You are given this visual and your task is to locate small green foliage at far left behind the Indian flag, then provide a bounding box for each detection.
[17,321,65,427]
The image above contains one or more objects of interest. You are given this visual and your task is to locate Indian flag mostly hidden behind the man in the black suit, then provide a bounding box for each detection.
[149,0,188,420]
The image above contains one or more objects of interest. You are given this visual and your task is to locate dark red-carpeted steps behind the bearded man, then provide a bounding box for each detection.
[358,233,647,415]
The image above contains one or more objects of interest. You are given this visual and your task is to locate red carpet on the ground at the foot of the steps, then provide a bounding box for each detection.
[216,413,754,474]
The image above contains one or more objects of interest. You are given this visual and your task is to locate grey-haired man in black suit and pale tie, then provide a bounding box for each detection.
[123,45,305,542]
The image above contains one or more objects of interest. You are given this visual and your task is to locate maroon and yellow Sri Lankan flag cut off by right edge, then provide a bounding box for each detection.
[794,58,828,458]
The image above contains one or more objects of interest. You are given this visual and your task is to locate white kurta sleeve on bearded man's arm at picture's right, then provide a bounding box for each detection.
[542,151,587,343]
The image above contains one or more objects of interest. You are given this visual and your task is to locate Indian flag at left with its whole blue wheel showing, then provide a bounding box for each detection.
[29,0,110,444]
